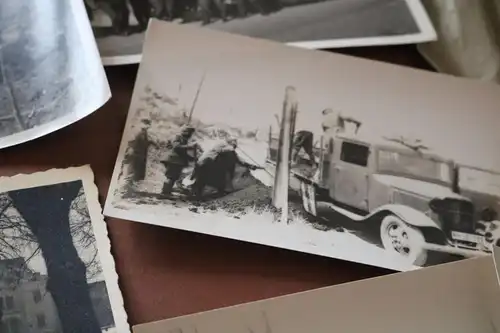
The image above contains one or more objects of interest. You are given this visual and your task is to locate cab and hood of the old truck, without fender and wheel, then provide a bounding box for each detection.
[318,135,457,213]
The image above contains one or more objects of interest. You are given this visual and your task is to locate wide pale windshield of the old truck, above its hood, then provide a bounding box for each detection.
[377,150,451,183]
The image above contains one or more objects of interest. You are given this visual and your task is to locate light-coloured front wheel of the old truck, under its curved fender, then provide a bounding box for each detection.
[380,215,428,266]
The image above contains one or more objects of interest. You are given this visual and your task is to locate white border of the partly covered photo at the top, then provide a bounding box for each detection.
[101,0,437,66]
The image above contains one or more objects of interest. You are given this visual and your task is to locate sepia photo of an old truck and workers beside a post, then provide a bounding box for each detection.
[104,20,500,271]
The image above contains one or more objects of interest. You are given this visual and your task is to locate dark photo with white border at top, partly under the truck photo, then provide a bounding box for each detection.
[89,0,436,65]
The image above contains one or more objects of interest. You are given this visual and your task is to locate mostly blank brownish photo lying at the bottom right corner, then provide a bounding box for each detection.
[133,247,500,333]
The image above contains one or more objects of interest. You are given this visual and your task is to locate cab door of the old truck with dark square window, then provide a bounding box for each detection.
[330,141,370,211]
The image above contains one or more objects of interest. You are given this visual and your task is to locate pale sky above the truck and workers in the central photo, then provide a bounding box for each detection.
[131,22,500,170]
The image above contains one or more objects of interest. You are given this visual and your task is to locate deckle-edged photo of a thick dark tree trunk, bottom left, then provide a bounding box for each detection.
[0,166,130,333]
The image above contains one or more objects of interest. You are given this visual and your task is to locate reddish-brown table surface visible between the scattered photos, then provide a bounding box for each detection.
[0,46,430,325]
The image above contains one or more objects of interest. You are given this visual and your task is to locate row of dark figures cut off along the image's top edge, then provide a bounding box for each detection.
[85,0,282,35]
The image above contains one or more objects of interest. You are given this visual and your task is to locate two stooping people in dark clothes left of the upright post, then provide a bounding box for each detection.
[161,126,261,200]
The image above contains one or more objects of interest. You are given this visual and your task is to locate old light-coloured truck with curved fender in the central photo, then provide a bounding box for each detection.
[267,128,500,266]
